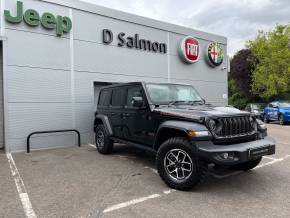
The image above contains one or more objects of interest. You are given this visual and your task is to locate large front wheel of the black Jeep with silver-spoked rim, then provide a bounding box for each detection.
[156,137,206,190]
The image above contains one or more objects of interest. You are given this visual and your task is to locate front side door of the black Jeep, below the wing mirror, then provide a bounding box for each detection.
[122,85,156,146]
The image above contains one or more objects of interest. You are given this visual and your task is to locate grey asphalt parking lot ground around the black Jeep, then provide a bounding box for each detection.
[0,124,290,218]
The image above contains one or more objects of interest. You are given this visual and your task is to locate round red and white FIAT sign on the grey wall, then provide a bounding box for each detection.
[178,36,200,64]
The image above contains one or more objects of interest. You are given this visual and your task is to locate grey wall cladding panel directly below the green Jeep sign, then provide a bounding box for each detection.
[6,29,71,70]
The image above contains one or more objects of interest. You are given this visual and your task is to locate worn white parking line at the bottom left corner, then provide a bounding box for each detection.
[6,153,36,218]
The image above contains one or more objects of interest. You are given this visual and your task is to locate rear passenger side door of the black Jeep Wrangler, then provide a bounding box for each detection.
[108,87,126,138]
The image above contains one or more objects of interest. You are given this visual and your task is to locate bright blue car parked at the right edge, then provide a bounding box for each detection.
[264,101,290,125]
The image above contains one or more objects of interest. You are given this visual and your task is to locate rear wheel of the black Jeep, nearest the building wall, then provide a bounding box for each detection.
[95,124,114,154]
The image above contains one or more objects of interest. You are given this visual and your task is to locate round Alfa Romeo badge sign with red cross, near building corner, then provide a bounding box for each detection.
[207,42,224,67]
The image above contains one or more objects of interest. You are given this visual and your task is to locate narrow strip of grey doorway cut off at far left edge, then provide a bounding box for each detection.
[0,42,4,148]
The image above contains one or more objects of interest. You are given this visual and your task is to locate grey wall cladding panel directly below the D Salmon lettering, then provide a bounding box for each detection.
[74,41,167,77]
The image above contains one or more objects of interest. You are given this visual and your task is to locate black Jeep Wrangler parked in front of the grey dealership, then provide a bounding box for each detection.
[94,82,275,190]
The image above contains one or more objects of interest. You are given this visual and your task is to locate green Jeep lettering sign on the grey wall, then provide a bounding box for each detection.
[4,1,72,36]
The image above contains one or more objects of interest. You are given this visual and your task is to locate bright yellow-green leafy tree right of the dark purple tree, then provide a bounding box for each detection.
[247,25,290,100]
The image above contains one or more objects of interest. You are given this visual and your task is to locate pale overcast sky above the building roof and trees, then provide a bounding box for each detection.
[83,0,290,55]
